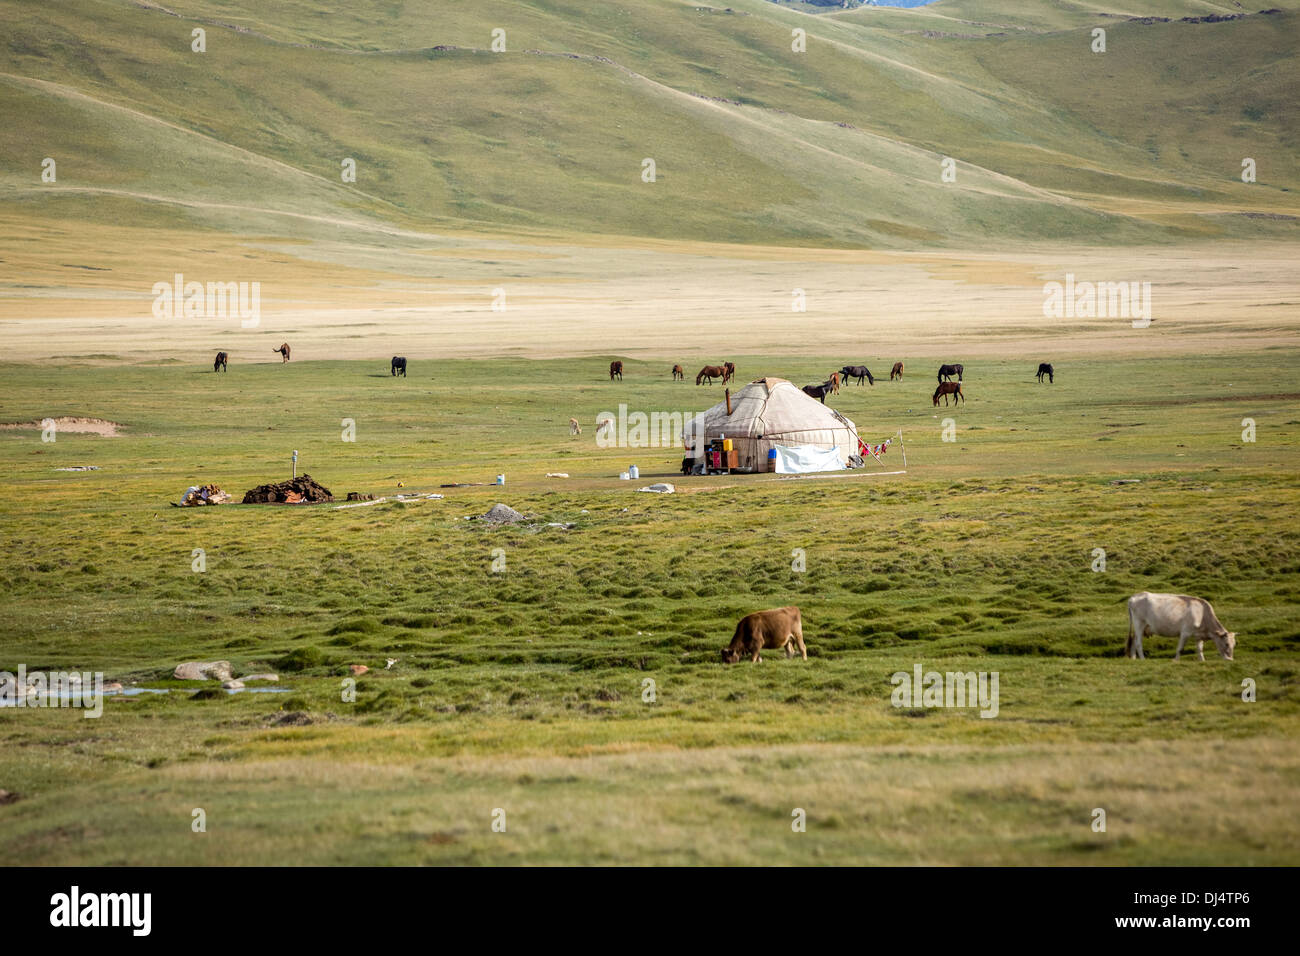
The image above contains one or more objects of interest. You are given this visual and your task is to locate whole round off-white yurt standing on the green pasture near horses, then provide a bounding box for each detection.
[681,378,858,473]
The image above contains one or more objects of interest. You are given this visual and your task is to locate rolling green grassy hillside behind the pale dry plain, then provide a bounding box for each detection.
[0,0,1300,247]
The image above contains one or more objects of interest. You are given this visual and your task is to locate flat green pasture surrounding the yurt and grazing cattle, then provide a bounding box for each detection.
[0,350,1300,865]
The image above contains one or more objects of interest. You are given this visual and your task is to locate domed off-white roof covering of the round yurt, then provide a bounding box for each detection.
[683,377,858,450]
